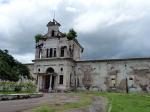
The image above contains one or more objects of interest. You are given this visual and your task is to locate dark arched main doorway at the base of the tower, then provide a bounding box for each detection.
[44,67,56,92]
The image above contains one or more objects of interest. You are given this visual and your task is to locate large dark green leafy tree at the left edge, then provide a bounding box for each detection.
[0,50,32,81]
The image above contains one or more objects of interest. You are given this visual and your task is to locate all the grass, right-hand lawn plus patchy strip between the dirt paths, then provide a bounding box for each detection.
[33,92,150,112]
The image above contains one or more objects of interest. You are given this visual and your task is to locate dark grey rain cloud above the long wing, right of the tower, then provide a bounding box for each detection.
[80,14,150,59]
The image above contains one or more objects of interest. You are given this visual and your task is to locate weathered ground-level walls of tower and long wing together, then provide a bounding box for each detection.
[26,59,150,92]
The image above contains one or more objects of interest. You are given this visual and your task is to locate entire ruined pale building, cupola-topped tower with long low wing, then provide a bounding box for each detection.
[26,20,150,92]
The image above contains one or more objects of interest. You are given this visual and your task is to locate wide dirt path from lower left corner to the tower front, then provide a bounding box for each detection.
[0,93,80,112]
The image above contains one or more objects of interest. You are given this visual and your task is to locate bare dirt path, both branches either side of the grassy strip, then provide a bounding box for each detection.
[0,93,107,112]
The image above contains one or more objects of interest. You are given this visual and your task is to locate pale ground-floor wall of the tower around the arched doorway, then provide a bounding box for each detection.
[34,59,75,89]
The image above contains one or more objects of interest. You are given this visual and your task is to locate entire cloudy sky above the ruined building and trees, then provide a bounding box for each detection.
[0,0,150,63]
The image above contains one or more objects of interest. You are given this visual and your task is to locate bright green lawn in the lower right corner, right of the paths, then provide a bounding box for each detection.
[99,93,150,112]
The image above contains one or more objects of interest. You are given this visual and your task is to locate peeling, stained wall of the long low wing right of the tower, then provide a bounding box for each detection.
[76,59,150,92]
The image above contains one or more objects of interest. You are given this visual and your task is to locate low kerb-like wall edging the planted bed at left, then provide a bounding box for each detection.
[0,93,43,101]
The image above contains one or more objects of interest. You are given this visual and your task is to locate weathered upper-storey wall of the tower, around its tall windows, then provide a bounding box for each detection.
[35,38,82,60]
